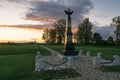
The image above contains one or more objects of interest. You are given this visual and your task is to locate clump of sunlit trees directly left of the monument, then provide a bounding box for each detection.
[42,19,66,44]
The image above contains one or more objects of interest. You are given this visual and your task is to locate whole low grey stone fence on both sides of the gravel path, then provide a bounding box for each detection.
[35,50,120,71]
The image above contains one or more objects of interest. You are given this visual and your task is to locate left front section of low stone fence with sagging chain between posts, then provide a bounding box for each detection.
[35,51,74,71]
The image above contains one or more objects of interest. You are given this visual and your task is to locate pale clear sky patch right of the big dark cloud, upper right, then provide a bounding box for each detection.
[88,0,120,26]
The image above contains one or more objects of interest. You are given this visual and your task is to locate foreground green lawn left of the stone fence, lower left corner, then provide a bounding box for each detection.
[0,54,34,80]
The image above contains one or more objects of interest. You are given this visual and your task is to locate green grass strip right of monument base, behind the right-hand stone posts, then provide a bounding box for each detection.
[76,46,120,59]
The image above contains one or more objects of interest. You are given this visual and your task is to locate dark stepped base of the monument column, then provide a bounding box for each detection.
[64,43,78,56]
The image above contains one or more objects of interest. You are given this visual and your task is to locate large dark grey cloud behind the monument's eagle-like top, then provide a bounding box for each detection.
[25,0,93,22]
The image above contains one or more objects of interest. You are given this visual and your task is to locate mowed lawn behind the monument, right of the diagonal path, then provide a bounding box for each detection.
[46,45,120,59]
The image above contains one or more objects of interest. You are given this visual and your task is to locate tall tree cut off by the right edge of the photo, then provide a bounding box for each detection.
[112,16,120,42]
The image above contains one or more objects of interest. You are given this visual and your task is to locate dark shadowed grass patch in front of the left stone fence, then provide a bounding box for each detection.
[37,69,81,80]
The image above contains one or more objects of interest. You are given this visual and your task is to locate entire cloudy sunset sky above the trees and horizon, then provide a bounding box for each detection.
[0,0,120,42]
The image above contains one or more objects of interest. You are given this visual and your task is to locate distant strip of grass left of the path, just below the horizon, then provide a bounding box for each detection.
[0,44,50,55]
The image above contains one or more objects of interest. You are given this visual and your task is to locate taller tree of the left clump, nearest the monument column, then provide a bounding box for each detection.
[53,19,66,44]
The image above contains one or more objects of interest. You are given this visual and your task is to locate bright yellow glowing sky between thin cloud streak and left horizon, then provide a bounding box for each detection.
[0,27,43,43]
